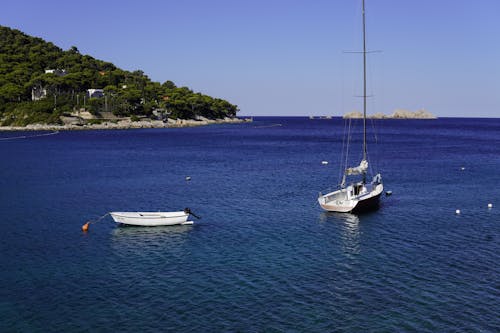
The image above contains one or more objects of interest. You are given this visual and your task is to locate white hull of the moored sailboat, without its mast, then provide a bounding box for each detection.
[318,183,384,213]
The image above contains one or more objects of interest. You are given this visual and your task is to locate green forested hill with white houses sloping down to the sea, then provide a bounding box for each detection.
[0,26,237,126]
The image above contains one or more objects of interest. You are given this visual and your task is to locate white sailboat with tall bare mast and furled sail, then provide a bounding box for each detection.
[318,0,384,213]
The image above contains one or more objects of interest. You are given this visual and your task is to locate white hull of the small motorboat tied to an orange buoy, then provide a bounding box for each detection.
[109,211,189,227]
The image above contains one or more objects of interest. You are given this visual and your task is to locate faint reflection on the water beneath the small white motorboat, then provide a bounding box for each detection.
[111,225,193,254]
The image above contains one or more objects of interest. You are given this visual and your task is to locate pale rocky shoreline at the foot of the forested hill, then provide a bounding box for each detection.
[0,117,252,131]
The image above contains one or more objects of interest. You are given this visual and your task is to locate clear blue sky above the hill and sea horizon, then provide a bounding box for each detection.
[0,0,500,117]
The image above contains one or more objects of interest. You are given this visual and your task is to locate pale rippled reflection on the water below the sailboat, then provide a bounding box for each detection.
[320,212,361,256]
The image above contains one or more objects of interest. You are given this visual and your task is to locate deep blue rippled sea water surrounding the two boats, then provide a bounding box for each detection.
[0,118,500,332]
